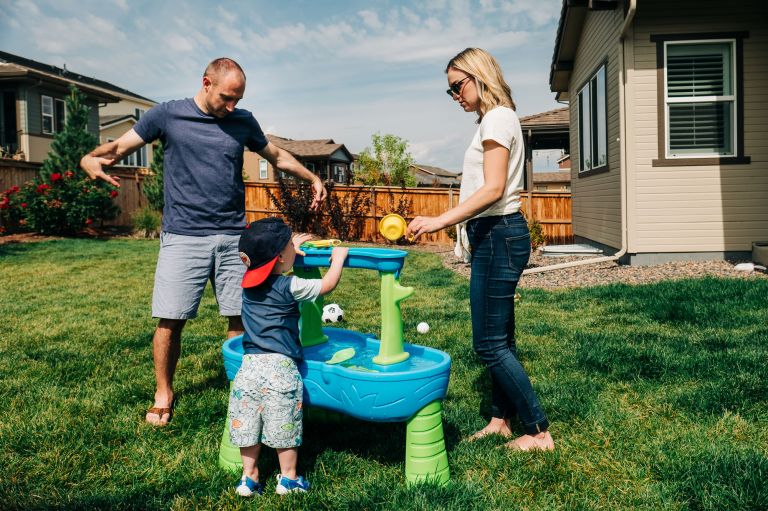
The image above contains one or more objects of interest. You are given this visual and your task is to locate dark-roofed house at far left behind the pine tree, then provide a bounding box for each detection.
[0,51,151,162]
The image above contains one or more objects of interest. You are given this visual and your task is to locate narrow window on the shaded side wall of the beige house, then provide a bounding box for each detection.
[578,64,608,172]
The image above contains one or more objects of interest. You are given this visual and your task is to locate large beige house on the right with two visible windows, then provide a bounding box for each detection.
[550,0,768,264]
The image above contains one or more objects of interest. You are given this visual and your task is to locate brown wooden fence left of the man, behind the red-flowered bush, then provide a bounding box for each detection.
[0,159,147,226]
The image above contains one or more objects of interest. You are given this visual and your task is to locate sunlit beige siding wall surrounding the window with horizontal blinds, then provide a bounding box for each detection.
[632,0,768,253]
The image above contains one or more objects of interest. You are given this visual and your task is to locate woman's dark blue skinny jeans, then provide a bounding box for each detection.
[467,213,549,435]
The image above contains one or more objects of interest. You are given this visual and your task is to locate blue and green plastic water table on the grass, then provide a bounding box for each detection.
[219,246,451,484]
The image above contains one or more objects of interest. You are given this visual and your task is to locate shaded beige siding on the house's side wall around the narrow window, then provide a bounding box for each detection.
[569,9,623,248]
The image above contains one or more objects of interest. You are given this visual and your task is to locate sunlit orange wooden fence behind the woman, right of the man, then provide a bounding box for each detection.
[245,183,573,245]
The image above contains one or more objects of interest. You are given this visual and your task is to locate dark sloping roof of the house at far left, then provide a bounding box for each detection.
[0,51,156,104]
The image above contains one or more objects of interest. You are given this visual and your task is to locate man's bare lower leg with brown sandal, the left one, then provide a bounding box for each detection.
[145,319,187,426]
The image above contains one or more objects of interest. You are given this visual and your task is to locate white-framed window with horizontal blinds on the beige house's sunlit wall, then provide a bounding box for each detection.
[664,40,736,158]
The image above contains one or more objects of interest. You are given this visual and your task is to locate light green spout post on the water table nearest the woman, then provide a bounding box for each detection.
[373,272,413,365]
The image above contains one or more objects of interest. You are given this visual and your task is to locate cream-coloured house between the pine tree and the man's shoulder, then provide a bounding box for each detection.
[99,91,157,168]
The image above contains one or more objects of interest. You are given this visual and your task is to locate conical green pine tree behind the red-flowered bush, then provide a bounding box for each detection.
[40,85,99,180]
